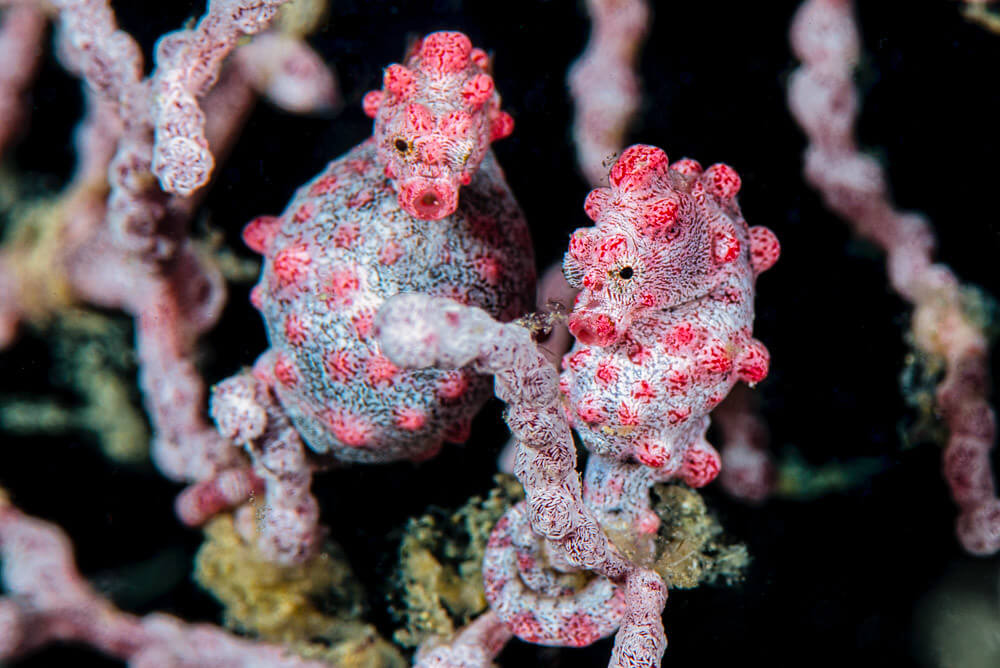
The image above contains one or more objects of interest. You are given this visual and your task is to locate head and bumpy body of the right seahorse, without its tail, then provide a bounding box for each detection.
[561,146,779,494]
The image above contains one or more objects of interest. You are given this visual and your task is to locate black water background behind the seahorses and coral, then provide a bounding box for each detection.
[0,0,1000,667]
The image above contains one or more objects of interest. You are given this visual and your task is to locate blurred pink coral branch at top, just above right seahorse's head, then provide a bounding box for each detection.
[569,0,650,185]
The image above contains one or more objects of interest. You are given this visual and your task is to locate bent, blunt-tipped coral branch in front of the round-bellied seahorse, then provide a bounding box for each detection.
[375,294,629,579]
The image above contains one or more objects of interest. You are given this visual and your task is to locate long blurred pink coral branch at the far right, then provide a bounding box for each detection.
[788,0,1000,555]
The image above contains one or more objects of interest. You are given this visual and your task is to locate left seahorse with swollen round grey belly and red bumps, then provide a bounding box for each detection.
[244,33,534,463]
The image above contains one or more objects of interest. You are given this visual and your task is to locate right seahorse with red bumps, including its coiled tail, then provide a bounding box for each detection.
[483,146,780,666]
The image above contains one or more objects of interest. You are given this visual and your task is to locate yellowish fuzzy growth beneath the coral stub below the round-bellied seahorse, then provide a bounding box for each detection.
[195,515,406,668]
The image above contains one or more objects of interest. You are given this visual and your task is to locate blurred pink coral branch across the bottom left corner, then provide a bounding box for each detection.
[0,500,325,668]
